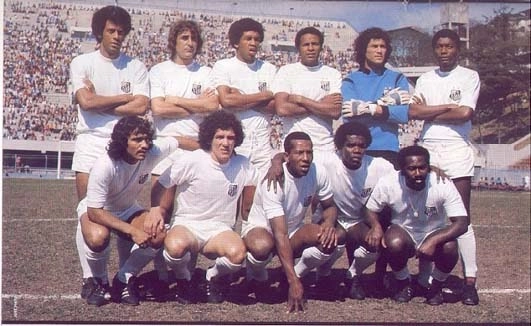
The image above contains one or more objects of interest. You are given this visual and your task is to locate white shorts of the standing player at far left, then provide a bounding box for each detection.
[72,134,110,173]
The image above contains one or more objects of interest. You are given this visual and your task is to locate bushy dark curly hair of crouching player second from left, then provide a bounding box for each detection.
[199,110,245,151]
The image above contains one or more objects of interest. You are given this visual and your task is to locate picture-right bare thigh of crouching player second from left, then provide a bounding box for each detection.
[202,230,247,264]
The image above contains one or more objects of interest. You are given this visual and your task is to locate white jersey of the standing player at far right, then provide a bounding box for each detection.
[415,66,480,141]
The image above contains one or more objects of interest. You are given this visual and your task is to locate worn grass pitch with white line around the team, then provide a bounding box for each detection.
[2,178,531,324]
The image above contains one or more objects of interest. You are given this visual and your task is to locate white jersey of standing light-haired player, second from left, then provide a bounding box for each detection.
[149,60,214,139]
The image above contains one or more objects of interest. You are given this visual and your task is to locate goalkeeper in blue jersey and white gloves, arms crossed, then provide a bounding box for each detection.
[341,28,410,170]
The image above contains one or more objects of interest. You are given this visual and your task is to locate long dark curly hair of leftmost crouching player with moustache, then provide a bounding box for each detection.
[107,116,155,160]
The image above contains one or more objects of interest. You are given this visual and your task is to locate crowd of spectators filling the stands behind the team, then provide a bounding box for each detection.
[3,1,419,143]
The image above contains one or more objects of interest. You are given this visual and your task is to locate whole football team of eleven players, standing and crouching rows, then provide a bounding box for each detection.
[70,6,479,311]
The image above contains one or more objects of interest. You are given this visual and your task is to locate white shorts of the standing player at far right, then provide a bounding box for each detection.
[420,140,474,179]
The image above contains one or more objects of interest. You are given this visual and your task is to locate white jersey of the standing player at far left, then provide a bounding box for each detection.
[70,51,149,138]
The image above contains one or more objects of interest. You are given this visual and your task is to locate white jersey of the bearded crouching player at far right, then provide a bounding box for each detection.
[366,171,467,242]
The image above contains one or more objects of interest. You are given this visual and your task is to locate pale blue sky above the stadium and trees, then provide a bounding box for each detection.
[179,0,530,31]
